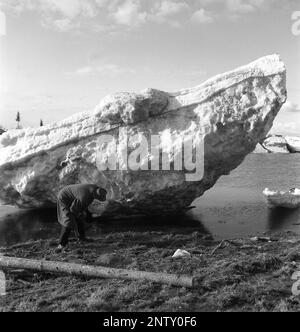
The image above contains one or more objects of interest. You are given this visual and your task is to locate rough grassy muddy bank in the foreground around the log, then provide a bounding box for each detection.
[0,231,300,312]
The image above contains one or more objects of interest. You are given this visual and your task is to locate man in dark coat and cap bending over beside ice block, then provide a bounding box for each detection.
[57,184,107,251]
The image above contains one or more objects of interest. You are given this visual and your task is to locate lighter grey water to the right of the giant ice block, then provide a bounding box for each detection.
[193,154,300,238]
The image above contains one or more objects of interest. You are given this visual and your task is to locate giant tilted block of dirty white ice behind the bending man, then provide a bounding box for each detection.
[0,55,286,216]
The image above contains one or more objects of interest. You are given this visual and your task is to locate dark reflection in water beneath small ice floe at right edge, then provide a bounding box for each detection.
[268,208,300,231]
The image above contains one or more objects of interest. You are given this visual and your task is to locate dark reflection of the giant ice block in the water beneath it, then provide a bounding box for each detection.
[0,209,208,246]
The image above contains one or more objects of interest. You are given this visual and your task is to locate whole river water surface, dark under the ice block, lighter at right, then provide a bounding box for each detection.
[0,154,300,246]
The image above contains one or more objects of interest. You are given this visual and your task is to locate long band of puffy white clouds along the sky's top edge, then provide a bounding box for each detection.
[1,0,289,33]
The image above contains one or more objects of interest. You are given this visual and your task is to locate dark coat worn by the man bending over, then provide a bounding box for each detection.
[57,184,98,227]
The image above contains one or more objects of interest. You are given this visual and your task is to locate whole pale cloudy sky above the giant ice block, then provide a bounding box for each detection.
[0,0,300,136]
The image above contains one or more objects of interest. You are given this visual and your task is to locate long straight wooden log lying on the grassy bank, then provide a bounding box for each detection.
[0,256,197,288]
